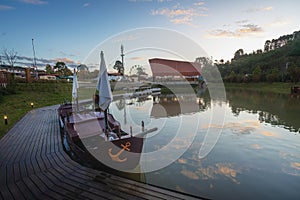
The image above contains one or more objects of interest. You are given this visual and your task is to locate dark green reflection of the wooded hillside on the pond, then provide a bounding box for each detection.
[226,89,300,131]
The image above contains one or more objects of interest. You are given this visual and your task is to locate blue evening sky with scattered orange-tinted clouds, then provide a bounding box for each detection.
[0,0,300,71]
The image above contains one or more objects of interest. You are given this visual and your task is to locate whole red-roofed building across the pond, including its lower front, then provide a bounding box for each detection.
[149,58,201,82]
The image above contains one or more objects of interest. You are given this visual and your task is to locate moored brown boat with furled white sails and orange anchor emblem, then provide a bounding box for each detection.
[58,52,157,172]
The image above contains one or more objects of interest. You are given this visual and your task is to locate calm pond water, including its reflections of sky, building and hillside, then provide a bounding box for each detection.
[111,90,300,199]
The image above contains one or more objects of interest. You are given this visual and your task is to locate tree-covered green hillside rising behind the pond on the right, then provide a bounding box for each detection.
[217,31,300,82]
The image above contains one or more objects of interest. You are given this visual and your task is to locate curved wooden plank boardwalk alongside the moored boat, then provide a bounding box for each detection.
[0,106,203,200]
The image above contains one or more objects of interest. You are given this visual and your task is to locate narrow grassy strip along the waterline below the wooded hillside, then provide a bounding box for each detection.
[224,83,293,95]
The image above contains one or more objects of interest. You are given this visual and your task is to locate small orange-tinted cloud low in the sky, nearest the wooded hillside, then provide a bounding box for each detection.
[209,22,263,37]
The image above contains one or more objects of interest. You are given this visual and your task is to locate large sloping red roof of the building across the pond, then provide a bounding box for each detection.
[149,58,201,77]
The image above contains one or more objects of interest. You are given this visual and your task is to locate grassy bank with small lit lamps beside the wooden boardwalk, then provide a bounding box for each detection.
[0,82,72,138]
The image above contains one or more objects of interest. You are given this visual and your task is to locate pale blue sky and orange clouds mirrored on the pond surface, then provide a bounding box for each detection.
[112,96,300,199]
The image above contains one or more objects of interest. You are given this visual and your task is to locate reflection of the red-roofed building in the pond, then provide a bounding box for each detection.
[151,95,207,118]
